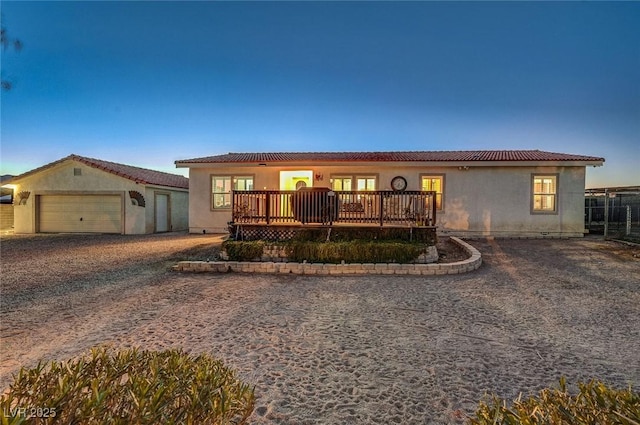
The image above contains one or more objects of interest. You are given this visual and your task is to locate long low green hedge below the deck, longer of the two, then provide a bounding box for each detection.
[287,240,425,263]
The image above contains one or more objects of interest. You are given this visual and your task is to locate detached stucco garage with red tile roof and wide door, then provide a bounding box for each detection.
[3,155,189,235]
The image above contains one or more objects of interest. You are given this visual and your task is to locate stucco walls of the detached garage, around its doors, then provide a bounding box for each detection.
[14,160,188,234]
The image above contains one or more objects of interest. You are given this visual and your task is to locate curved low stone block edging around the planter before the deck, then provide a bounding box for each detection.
[172,236,482,276]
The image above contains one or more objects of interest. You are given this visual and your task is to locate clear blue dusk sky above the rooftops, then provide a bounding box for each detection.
[0,1,640,187]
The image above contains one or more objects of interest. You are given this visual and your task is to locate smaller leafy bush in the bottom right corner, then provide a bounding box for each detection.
[469,378,640,425]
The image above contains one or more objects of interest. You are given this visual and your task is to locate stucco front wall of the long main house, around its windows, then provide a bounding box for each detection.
[184,164,585,237]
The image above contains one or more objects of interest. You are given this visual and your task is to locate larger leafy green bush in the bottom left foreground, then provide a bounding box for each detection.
[0,348,255,425]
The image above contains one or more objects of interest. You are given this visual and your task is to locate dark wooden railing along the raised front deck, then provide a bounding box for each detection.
[231,188,436,226]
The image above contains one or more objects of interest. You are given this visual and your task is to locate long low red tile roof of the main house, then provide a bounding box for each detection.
[176,150,604,166]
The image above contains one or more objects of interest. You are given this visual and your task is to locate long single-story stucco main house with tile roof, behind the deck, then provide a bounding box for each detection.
[175,150,604,237]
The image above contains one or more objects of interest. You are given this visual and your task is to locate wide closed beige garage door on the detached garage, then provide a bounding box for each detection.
[39,195,122,233]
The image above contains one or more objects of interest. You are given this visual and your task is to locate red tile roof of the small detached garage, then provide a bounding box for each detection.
[12,154,189,189]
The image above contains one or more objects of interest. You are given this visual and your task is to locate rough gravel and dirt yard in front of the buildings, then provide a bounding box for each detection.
[0,234,640,424]
